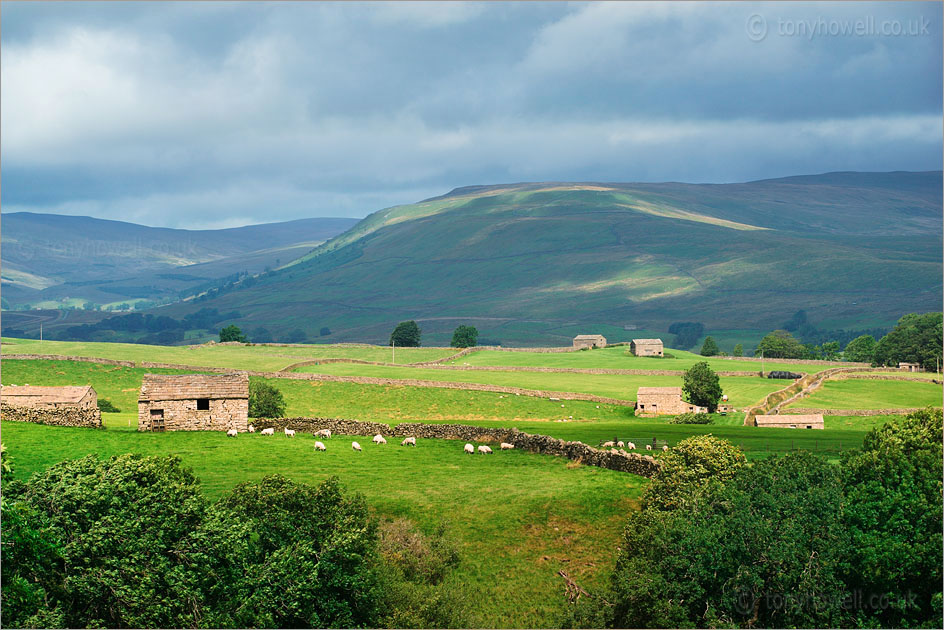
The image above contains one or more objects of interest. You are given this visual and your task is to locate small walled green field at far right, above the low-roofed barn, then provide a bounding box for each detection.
[788,379,942,409]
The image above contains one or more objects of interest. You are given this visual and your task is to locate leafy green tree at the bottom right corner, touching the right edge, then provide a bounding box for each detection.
[842,408,944,628]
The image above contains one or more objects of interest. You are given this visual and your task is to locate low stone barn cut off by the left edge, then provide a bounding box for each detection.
[0,385,102,427]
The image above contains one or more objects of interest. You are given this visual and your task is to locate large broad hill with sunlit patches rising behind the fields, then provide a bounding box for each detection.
[162,172,942,349]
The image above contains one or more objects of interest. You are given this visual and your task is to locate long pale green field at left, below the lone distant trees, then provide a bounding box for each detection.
[3,338,458,371]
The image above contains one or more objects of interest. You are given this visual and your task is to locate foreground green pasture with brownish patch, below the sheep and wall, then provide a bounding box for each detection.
[2,422,645,627]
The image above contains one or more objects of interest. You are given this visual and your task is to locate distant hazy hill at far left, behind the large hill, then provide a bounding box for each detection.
[2,212,357,308]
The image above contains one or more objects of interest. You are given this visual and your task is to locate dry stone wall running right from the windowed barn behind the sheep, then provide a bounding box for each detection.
[253,418,662,477]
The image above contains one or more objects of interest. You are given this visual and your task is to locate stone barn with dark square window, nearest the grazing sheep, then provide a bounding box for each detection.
[138,373,249,431]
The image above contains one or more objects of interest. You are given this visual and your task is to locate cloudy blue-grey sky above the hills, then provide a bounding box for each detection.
[0,1,944,229]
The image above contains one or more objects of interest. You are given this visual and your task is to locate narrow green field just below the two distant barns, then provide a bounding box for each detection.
[449,346,843,374]
